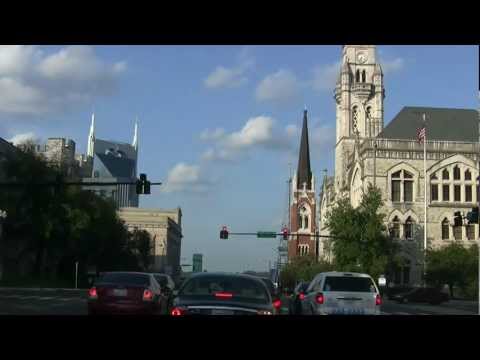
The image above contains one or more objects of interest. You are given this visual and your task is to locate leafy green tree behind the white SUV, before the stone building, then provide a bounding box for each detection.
[326,184,399,279]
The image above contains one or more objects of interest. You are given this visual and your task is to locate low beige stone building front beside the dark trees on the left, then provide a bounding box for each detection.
[118,207,183,276]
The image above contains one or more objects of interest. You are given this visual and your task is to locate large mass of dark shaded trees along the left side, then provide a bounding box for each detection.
[0,148,140,284]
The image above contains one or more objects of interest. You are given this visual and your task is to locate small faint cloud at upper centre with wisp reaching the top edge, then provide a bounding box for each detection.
[204,47,254,89]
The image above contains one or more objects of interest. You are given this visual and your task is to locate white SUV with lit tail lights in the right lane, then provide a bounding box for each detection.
[302,271,382,315]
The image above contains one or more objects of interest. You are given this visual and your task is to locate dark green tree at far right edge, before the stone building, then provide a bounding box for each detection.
[426,243,478,297]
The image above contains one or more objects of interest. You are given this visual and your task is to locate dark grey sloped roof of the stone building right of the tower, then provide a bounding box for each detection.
[378,106,479,142]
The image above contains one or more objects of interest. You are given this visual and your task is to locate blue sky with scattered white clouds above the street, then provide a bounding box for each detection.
[0,45,479,272]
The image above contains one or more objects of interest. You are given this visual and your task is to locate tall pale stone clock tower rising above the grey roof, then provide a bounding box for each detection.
[335,45,385,194]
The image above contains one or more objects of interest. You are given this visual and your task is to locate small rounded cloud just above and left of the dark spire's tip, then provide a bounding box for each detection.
[255,69,300,102]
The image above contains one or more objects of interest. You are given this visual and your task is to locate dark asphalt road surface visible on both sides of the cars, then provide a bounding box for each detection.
[0,288,478,315]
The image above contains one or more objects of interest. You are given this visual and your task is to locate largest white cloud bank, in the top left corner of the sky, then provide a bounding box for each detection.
[0,45,127,115]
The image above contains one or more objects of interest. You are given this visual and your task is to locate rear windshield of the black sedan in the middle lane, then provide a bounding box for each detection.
[179,276,270,303]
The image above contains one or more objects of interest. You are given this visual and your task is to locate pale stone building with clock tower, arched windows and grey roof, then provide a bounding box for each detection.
[316,45,480,285]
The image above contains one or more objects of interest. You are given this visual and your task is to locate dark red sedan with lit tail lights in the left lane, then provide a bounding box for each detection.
[88,272,168,315]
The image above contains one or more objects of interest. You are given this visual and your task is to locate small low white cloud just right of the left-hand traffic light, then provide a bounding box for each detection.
[162,162,212,193]
